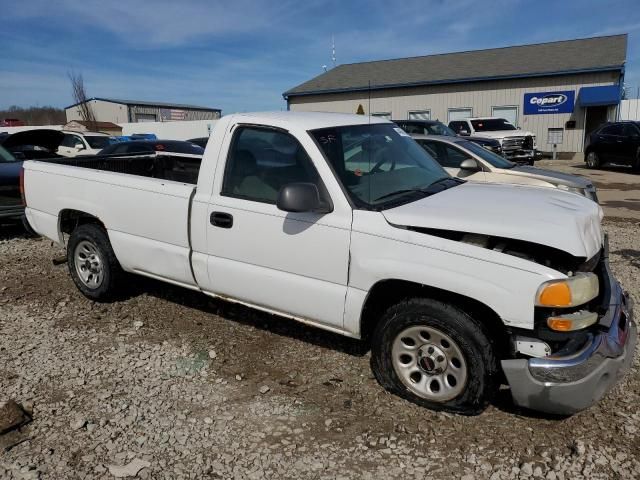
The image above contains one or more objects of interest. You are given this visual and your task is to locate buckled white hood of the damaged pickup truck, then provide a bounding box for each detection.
[382,182,603,259]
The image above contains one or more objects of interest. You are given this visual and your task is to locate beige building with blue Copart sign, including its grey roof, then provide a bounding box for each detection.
[283,35,627,152]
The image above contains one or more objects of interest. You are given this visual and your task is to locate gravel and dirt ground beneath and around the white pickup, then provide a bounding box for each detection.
[0,221,640,480]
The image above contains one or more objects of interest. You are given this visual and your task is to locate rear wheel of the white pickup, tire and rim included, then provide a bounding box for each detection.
[67,224,124,302]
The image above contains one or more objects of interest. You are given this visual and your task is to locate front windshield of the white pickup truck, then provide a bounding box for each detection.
[310,124,458,209]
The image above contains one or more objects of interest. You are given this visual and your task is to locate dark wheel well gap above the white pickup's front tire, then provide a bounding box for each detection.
[360,280,509,358]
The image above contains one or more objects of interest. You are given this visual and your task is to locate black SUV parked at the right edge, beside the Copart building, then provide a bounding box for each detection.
[584,121,640,171]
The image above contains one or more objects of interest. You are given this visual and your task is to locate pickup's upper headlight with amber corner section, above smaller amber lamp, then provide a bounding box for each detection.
[536,273,600,308]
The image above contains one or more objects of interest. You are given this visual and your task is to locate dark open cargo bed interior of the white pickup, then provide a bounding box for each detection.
[38,152,202,185]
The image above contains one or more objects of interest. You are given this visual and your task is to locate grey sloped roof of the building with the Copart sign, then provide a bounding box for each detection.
[283,34,627,99]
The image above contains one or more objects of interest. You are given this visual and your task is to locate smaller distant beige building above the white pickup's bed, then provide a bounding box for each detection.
[65,97,222,123]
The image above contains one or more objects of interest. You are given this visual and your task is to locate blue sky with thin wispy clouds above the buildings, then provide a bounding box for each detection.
[0,0,640,113]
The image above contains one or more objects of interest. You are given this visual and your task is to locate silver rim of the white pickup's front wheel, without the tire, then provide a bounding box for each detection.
[391,325,467,402]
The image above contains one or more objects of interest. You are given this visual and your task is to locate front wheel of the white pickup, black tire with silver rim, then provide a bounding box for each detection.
[371,298,498,415]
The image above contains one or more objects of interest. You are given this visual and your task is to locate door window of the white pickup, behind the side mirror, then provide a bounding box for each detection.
[221,127,322,204]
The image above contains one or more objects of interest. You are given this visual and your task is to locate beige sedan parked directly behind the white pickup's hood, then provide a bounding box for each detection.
[412,135,598,202]
